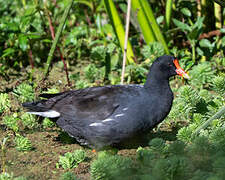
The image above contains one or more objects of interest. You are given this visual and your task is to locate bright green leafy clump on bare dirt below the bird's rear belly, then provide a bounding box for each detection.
[56,149,86,169]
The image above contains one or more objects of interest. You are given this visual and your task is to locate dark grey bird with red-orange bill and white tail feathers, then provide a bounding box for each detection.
[23,55,189,149]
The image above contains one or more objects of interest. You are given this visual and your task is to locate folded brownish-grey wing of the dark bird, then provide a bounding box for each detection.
[41,86,130,120]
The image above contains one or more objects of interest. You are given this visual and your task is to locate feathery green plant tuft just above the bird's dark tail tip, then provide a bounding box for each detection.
[13,83,34,103]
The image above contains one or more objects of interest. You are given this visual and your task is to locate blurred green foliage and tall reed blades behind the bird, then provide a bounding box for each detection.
[0,0,225,83]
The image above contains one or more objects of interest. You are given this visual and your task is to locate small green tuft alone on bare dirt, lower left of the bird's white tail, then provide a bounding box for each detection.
[15,135,33,151]
